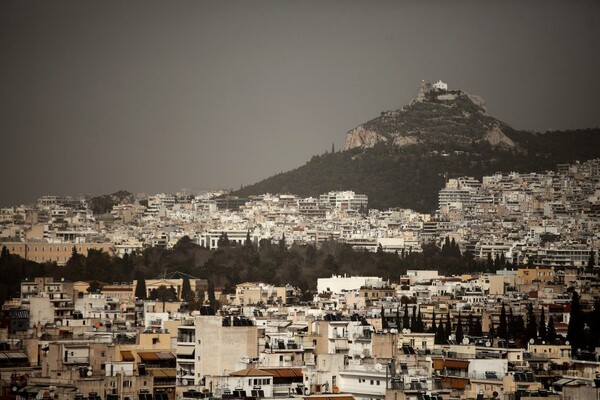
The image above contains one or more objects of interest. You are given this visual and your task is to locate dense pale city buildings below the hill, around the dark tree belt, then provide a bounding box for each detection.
[0,160,600,400]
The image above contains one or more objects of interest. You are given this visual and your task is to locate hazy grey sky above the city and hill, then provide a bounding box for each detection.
[0,0,600,205]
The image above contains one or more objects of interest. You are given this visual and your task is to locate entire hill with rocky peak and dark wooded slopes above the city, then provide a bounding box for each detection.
[232,82,600,212]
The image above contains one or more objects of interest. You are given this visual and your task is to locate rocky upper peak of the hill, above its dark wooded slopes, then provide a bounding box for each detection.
[346,83,517,150]
